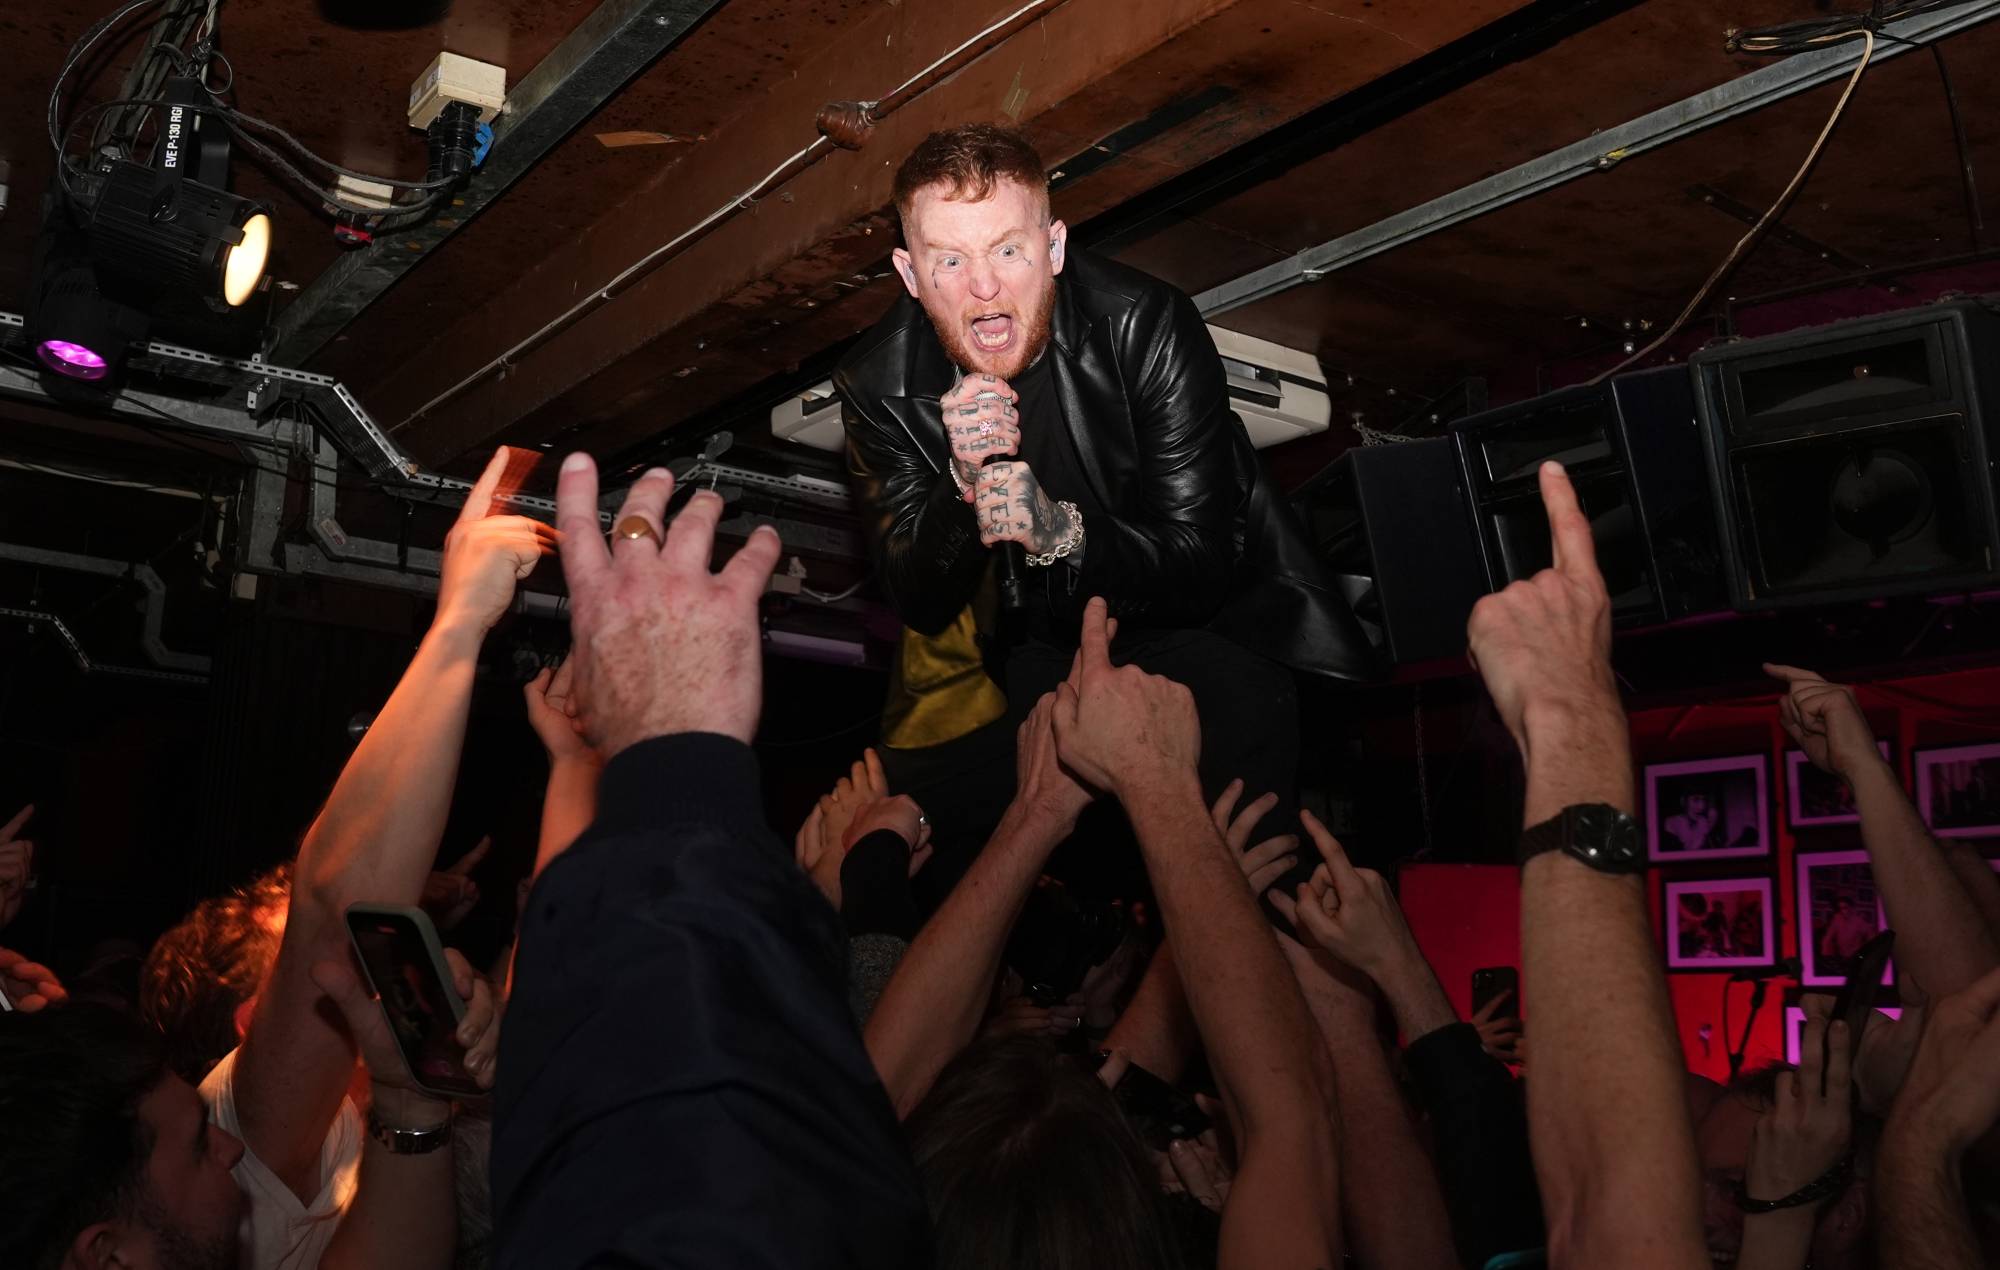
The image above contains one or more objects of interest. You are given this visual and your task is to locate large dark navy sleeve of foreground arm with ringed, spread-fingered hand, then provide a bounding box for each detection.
[492,734,930,1270]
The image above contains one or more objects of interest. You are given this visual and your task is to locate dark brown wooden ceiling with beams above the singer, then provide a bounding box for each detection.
[0,0,2000,516]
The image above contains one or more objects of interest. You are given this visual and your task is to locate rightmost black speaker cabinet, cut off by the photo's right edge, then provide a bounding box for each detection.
[1692,300,2000,608]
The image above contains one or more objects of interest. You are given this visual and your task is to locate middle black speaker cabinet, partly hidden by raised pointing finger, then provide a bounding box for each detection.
[1452,366,1726,626]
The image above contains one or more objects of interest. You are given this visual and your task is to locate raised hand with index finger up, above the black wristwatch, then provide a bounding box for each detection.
[1466,462,1622,754]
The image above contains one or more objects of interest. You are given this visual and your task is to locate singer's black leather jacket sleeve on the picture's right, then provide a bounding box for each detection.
[1078,290,1242,626]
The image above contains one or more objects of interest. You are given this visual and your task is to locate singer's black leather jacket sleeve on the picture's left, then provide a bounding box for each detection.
[836,378,992,636]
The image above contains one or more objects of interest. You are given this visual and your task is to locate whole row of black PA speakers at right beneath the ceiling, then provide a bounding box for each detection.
[1300,300,2000,664]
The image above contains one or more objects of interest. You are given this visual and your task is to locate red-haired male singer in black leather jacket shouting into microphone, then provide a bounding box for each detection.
[834,124,1372,864]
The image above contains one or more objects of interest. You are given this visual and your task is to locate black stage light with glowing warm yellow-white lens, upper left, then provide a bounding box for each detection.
[90,160,270,308]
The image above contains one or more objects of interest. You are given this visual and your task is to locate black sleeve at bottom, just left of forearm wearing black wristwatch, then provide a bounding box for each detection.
[1404,1022,1546,1266]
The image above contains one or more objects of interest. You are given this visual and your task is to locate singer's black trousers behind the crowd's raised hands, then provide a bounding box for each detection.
[882,630,1318,912]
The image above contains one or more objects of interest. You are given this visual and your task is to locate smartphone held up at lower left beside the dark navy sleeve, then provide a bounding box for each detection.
[348,904,486,1098]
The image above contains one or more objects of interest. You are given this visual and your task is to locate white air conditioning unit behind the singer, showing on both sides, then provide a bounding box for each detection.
[770,326,1334,452]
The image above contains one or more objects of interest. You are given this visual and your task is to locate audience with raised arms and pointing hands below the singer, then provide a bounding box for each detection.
[0,458,2000,1270]
